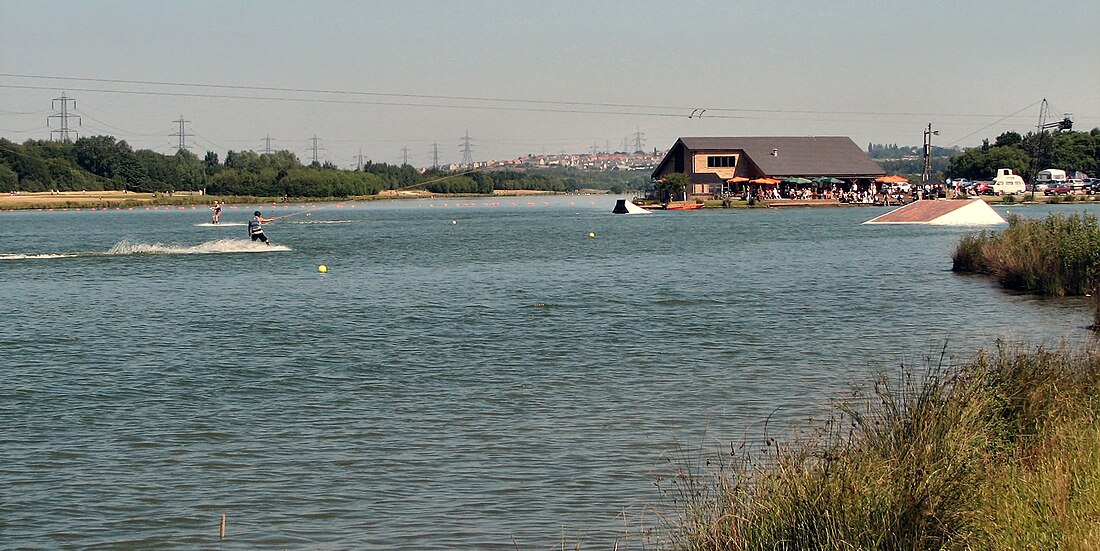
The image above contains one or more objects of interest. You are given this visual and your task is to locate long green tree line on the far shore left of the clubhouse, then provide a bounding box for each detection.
[0,135,649,198]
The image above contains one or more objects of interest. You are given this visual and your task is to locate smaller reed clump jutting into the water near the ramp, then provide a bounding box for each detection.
[952,213,1100,296]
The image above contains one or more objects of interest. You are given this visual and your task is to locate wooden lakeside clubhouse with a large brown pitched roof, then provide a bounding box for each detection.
[652,136,886,197]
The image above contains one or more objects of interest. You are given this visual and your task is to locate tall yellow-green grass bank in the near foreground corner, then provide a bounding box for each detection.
[662,345,1100,551]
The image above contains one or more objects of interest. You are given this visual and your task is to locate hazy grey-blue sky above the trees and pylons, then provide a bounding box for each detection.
[0,0,1100,167]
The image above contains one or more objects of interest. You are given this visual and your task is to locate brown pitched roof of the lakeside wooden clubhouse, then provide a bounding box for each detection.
[673,136,886,178]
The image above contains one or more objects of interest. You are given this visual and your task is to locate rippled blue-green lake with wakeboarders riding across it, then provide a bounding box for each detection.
[0,196,1100,550]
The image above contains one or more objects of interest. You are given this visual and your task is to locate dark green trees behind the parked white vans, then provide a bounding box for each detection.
[945,129,1100,181]
